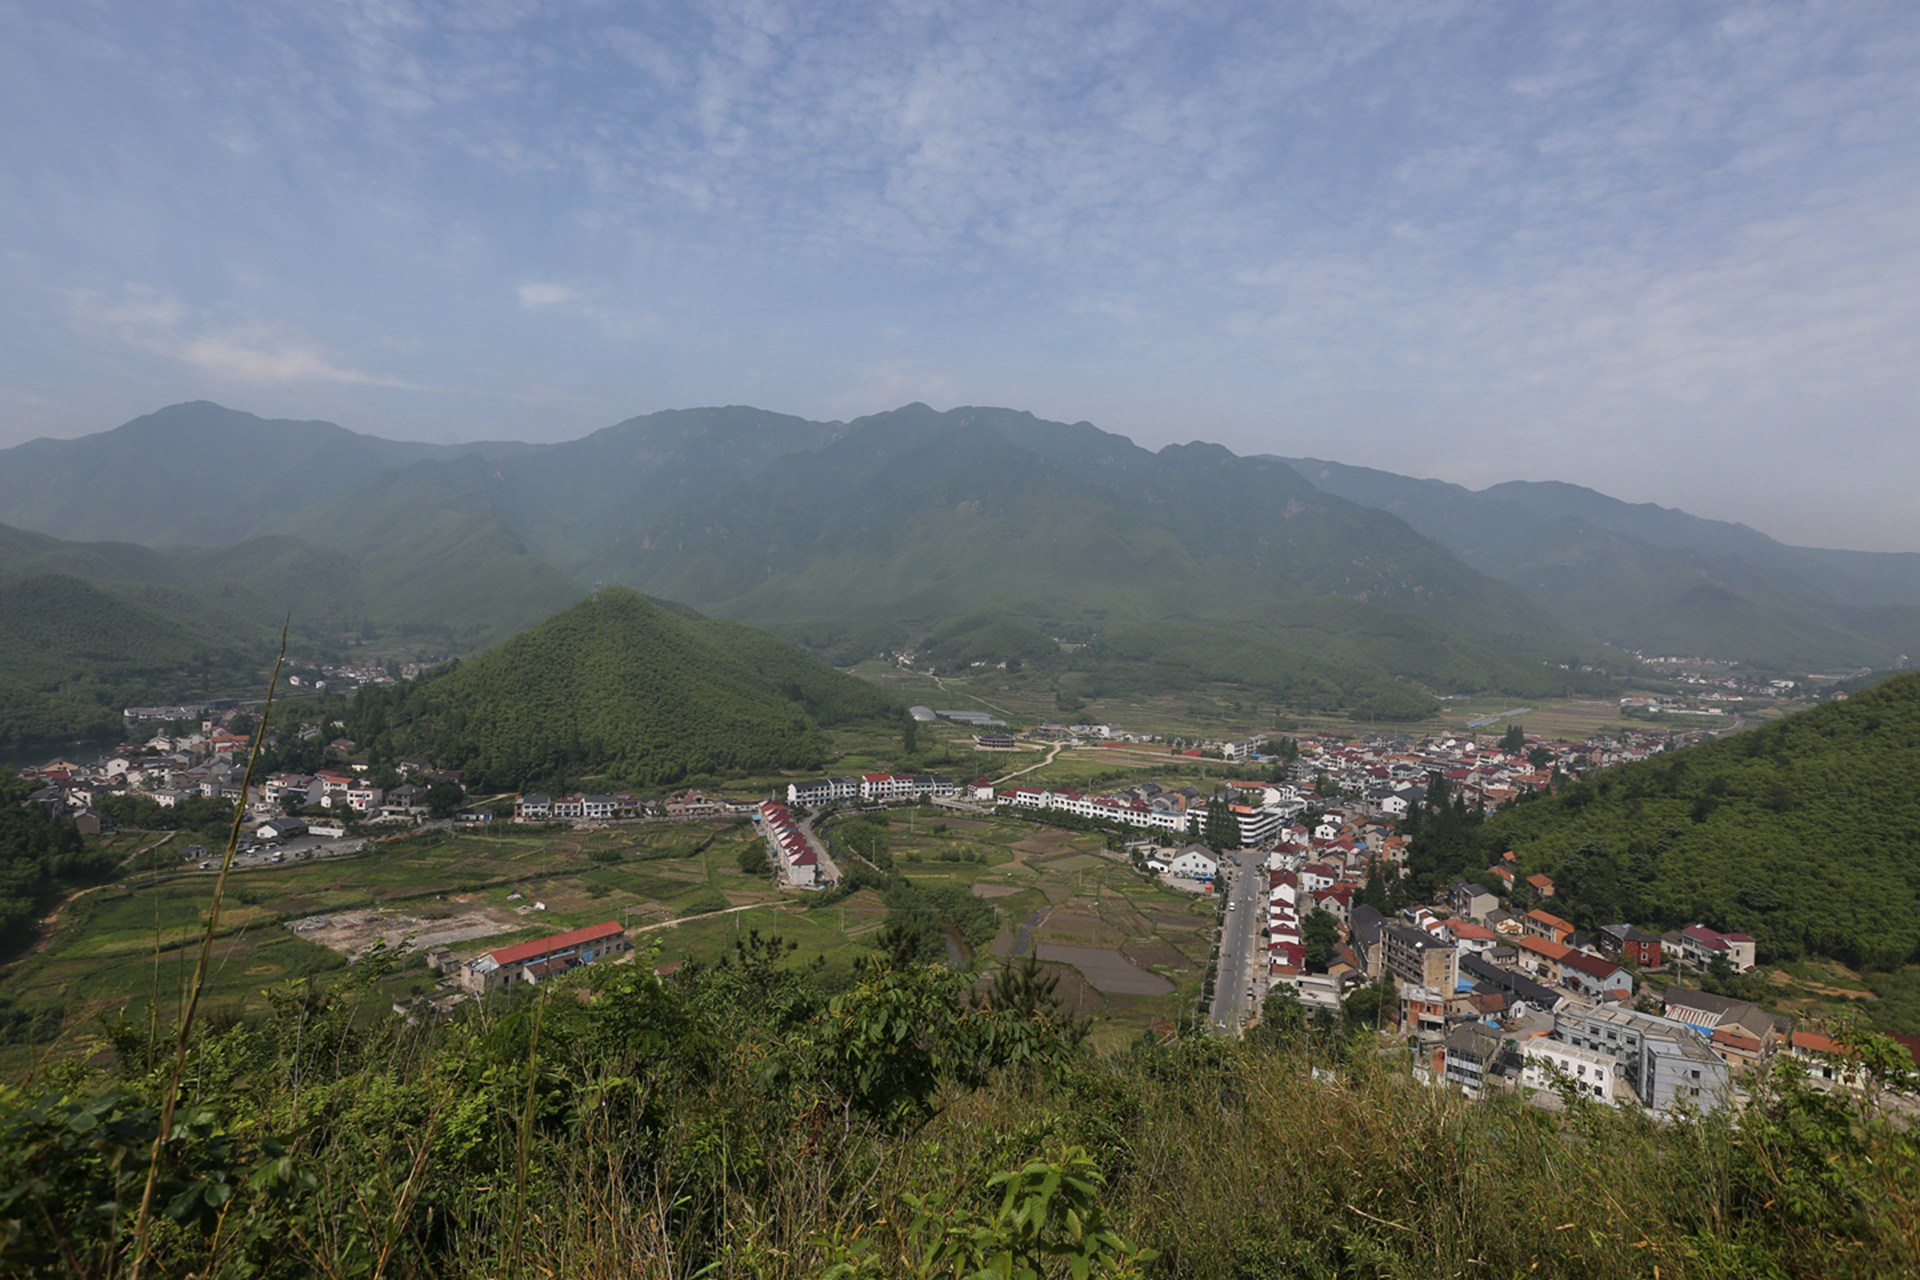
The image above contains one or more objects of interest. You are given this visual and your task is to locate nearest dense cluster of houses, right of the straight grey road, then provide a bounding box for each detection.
[1263,850,1920,1113]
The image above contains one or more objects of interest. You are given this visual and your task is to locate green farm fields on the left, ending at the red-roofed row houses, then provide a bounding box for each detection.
[0,821,783,1073]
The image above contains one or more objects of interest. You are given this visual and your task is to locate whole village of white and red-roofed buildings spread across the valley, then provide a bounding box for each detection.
[7,704,1920,1115]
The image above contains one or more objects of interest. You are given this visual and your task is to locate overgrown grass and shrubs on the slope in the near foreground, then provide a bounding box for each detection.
[0,935,1920,1280]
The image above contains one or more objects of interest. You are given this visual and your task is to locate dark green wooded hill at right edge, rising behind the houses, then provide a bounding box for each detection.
[1413,674,1920,969]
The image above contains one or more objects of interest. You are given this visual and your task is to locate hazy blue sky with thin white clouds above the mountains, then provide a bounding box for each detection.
[0,0,1920,549]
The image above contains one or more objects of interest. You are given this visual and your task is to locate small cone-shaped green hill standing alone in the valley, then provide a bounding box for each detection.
[349,587,900,791]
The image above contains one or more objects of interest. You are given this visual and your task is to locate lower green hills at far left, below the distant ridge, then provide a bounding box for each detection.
[0,499,582,748]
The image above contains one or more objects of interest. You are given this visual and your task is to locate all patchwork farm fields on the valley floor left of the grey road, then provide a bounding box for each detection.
[0,810,1213,1079]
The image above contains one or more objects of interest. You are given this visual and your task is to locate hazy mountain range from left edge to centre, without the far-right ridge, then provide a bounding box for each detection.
[0,403,1620,718]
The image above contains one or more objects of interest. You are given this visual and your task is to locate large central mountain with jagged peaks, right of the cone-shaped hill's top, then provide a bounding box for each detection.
[595,405,1612,700]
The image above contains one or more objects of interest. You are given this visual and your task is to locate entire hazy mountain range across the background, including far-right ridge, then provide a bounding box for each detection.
[0,401,1920,740]
